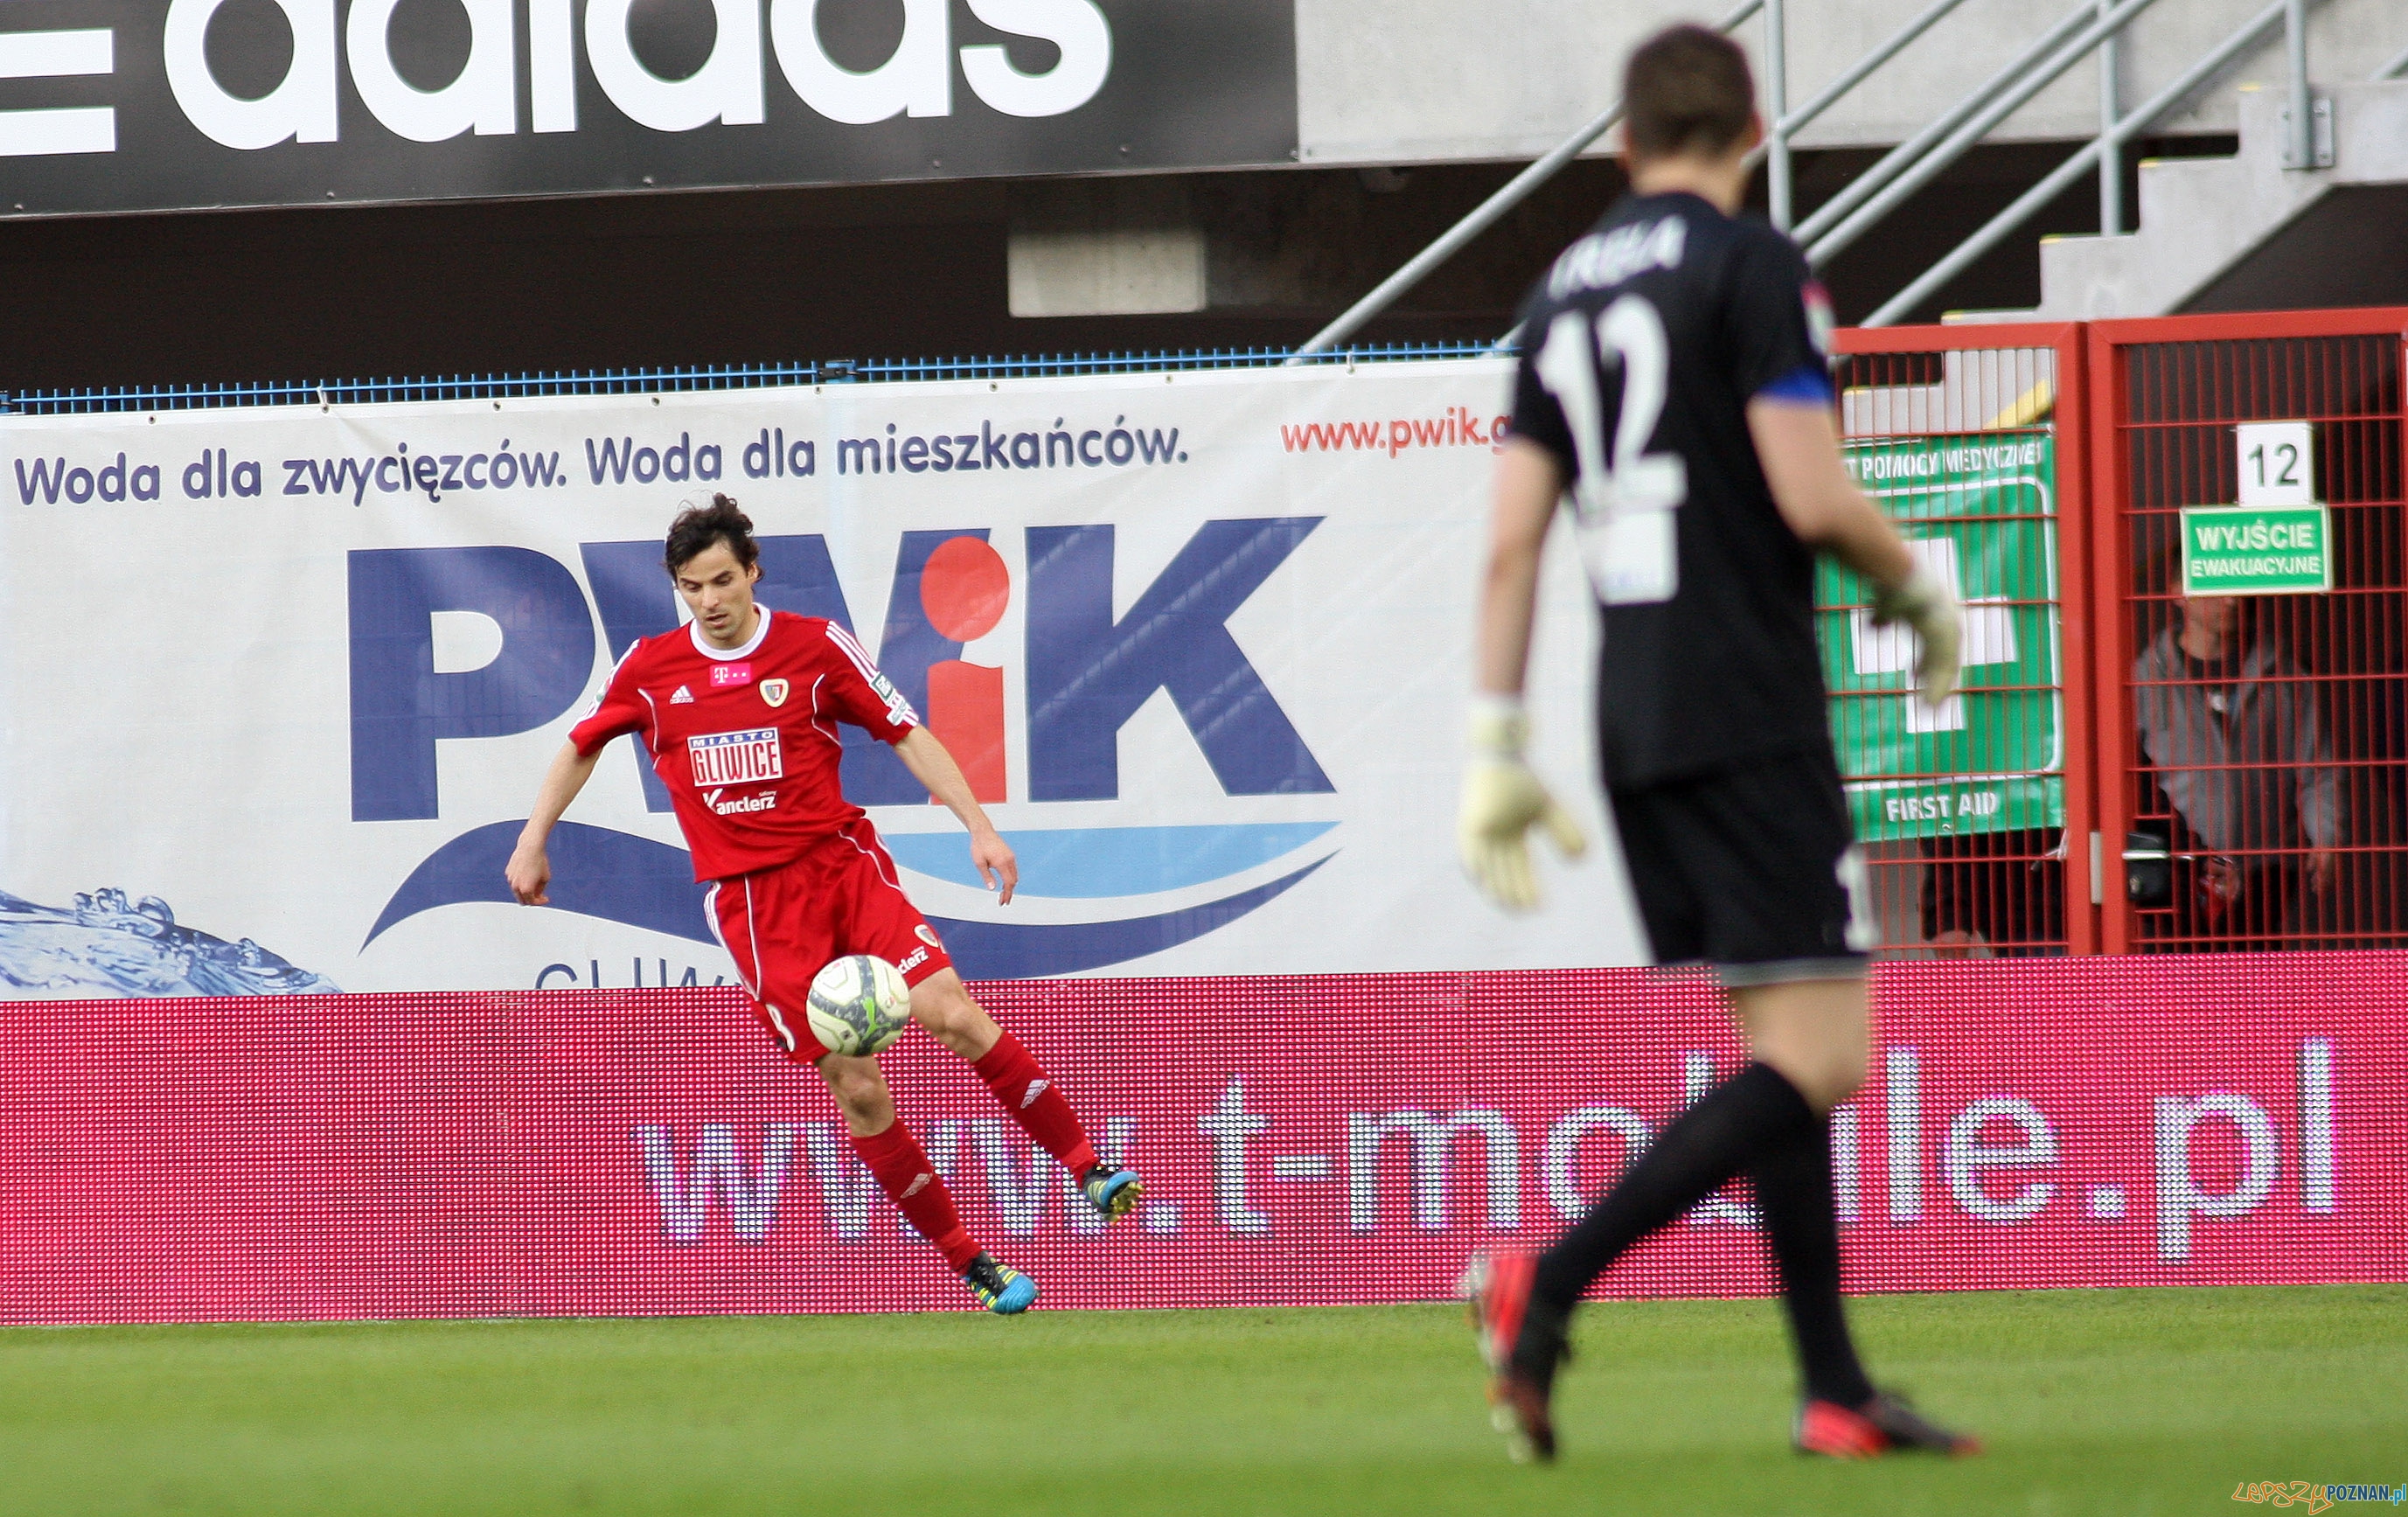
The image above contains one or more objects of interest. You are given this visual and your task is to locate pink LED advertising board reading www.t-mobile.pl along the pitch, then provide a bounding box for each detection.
[0,954,2408,1322]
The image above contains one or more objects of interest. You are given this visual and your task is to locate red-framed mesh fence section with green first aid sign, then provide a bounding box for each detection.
[1818,323,2098,956]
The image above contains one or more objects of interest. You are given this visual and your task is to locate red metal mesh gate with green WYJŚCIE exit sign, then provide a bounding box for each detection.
[2088,309,2408,954]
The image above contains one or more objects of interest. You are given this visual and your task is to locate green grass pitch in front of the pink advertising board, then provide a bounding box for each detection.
[0,1286,2408,1517]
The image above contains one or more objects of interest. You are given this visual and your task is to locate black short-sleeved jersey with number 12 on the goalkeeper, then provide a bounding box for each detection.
[1513,192,1830,790]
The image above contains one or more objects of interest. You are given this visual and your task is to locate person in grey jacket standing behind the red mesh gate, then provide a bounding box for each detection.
[2131,595,2341,946]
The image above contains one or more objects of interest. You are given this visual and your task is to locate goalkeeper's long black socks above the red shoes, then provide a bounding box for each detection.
[1532,1064,1874,1406]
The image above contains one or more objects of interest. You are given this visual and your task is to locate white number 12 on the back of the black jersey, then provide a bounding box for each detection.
[1539,294,1688,607]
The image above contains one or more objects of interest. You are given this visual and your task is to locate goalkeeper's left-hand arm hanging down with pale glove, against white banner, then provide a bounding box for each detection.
[1454,438,1587,910]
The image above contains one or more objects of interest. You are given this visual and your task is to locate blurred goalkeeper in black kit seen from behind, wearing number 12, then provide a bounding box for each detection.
[1459,26,1977,1459]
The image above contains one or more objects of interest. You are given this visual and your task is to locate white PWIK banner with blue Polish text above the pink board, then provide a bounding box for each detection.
[0,361,1642,997]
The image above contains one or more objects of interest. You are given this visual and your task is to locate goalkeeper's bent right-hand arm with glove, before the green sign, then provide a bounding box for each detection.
[1748,397,1963,706]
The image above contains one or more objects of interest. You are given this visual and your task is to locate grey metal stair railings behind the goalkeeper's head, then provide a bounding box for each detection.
[1288,0,2408,353]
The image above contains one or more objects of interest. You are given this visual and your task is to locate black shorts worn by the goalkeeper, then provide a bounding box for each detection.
[1609,748,1874,985]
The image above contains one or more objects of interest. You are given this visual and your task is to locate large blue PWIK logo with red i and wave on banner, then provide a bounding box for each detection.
[349,518,1336,978]
